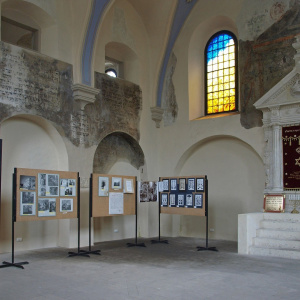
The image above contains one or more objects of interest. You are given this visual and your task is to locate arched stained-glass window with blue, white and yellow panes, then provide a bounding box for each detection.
[205,31,238,115]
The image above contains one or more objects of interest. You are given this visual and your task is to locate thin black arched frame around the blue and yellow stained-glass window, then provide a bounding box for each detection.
[204,30,239,117]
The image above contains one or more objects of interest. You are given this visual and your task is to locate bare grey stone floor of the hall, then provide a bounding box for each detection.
[0,238,300,300]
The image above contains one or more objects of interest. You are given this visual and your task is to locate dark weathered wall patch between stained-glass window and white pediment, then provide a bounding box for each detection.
[239,1,300,129]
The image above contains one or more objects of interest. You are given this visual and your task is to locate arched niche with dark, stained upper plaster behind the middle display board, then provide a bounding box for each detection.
[93,132,147,242]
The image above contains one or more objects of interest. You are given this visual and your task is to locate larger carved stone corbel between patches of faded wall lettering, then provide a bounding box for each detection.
[72,83,100,110]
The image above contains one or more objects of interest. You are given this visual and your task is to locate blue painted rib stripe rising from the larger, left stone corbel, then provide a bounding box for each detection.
[81,0,110,85]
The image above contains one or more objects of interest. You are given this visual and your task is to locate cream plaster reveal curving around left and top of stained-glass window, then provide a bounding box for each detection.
[188,16,238,120]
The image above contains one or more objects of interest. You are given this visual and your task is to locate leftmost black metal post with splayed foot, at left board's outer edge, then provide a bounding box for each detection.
[0,169,29,269]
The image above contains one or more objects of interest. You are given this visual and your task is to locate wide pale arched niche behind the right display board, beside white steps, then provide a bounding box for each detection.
[175,135,265,241]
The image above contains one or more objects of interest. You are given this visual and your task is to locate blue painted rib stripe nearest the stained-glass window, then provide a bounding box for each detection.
[156,0,197,107]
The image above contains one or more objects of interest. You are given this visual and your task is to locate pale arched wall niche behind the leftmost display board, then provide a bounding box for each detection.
[0,115,68,253]
